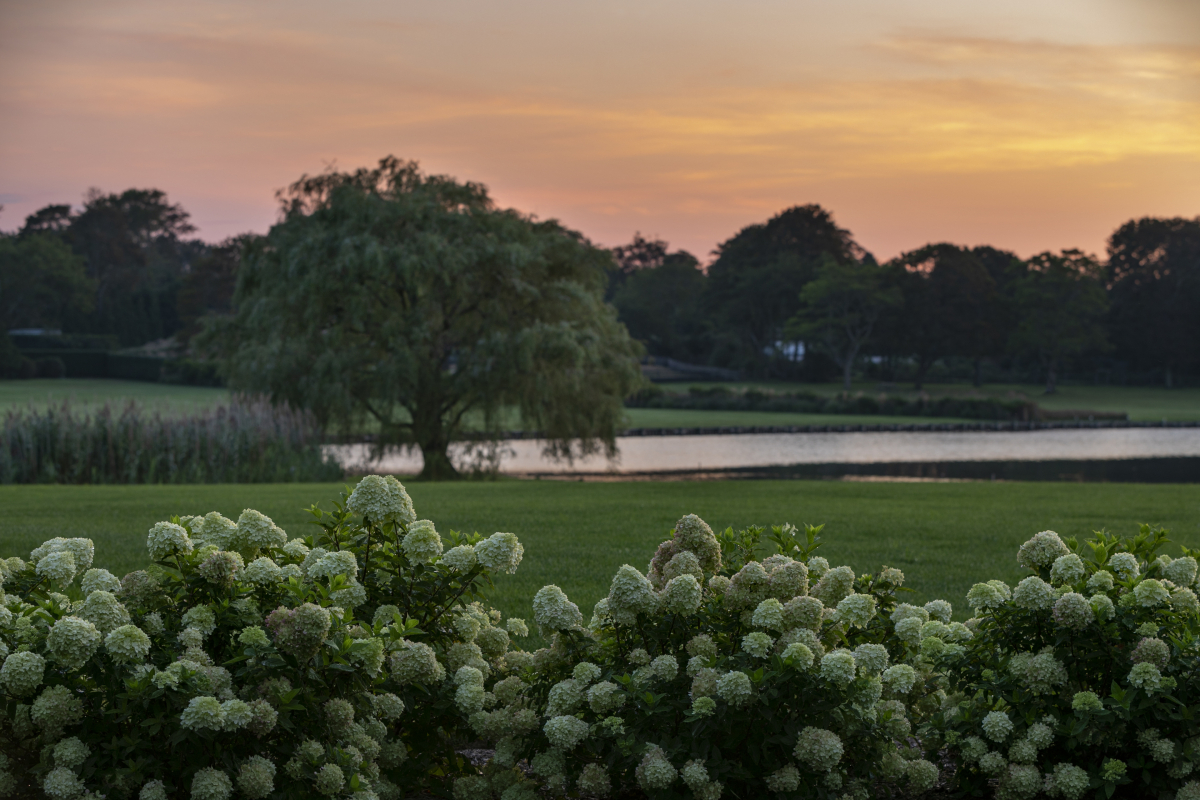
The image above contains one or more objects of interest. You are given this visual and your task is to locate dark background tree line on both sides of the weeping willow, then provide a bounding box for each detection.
[0,171,1200,391]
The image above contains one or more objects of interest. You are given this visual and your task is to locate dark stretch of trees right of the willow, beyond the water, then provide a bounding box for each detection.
[608,205,1200,392]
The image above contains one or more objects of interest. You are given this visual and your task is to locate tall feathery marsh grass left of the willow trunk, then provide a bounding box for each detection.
[0,399,343,483]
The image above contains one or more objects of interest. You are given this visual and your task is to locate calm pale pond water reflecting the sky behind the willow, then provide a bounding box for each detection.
[330,428,1200,473]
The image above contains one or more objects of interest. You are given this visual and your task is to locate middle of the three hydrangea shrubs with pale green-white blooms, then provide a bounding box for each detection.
[456,515,945,800]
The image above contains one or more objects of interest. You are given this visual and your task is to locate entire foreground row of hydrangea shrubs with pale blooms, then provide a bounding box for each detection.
[0,476,1200,800]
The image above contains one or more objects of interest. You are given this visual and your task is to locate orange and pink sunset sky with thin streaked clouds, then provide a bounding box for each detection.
[0,0,1200,259]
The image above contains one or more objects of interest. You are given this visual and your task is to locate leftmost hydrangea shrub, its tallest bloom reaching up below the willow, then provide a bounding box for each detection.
[0,476,526,800]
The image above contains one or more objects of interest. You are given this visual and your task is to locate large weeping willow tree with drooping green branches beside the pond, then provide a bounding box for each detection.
[205,157,641,480]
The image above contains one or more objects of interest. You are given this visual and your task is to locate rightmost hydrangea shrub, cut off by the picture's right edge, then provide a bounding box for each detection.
[924,525,1200,800]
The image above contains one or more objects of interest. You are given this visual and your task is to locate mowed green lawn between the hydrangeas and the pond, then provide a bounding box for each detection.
[0,481,1200,633]
